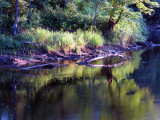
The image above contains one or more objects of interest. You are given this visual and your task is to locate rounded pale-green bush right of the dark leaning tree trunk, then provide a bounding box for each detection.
[110,16,148,45]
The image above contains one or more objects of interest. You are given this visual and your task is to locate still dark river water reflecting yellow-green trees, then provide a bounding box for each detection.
[0,48,160,120]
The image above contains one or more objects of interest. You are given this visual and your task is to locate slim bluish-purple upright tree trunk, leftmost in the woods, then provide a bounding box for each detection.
[13,0,18,35]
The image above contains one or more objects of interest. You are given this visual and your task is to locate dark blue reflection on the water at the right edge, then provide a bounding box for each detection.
[131,47,160,98]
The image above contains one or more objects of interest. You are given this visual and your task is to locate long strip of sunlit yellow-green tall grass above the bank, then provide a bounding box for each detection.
[20,28,104,52]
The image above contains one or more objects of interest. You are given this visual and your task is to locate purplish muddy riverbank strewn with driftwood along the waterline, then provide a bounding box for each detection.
[0,42,157,69]
